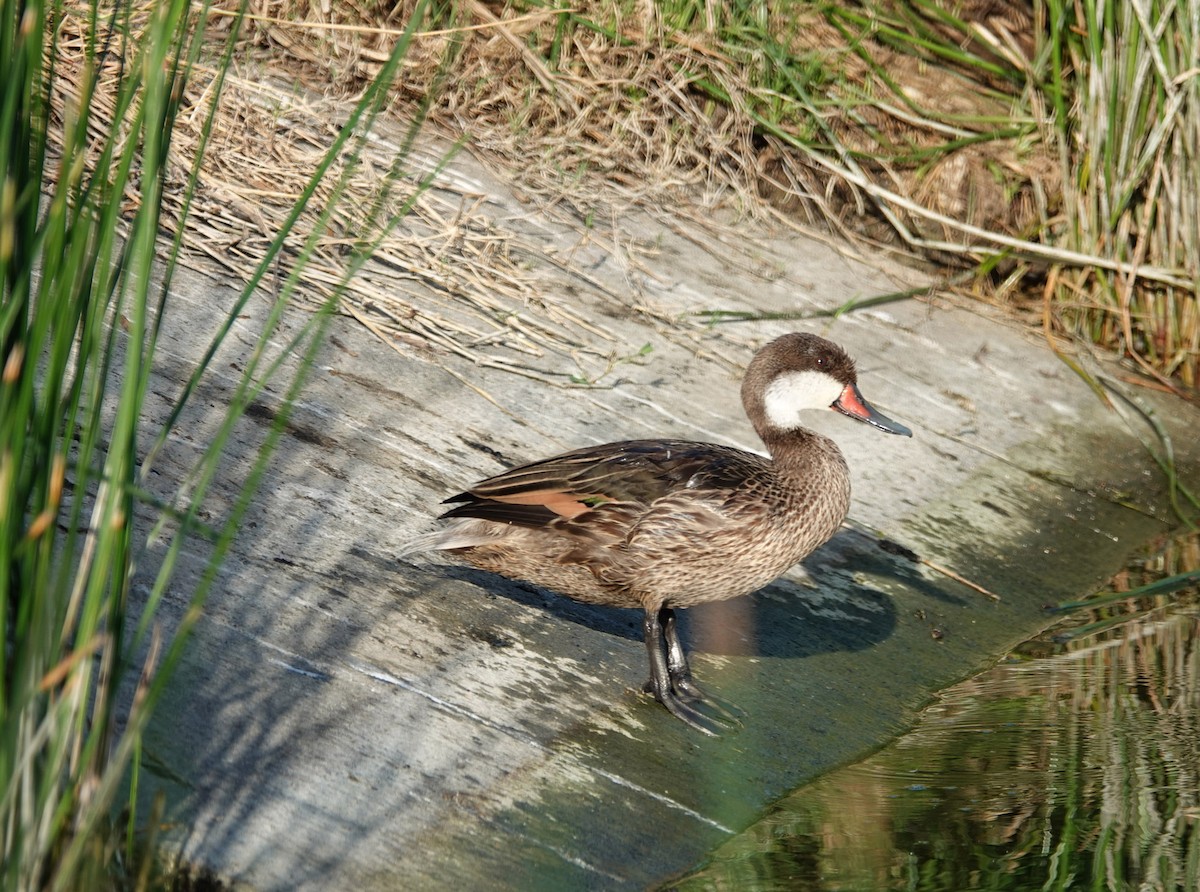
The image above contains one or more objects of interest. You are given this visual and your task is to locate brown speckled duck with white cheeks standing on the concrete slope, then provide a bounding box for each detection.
[401,333,912,735]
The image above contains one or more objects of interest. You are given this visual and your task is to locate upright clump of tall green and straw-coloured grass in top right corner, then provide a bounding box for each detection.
[1045,0,1200,388]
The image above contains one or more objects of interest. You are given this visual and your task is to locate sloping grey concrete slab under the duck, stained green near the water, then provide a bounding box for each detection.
[136,138,1200,892]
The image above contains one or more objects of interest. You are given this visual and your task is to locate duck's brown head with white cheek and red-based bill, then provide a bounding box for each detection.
[742,333,912,439]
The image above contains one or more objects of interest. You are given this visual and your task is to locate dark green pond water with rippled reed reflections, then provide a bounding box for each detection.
[671,534,1200,892]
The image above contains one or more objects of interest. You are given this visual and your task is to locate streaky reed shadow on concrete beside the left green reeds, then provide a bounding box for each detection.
[134,352,420,888]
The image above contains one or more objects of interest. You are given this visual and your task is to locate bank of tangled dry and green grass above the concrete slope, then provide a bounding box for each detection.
[252,0,1200,385]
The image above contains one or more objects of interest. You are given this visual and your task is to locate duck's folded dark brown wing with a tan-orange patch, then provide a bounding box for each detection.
[442,441,766,535]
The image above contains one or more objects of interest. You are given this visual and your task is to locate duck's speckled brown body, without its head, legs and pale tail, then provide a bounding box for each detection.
[443,431,850,611]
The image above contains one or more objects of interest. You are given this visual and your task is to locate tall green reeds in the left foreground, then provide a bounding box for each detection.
[0,0,441,890]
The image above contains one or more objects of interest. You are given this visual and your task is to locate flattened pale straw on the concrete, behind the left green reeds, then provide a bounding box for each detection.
[51,4,667,384]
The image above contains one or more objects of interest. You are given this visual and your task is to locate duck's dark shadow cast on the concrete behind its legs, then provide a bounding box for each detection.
[439,529,946,658]
